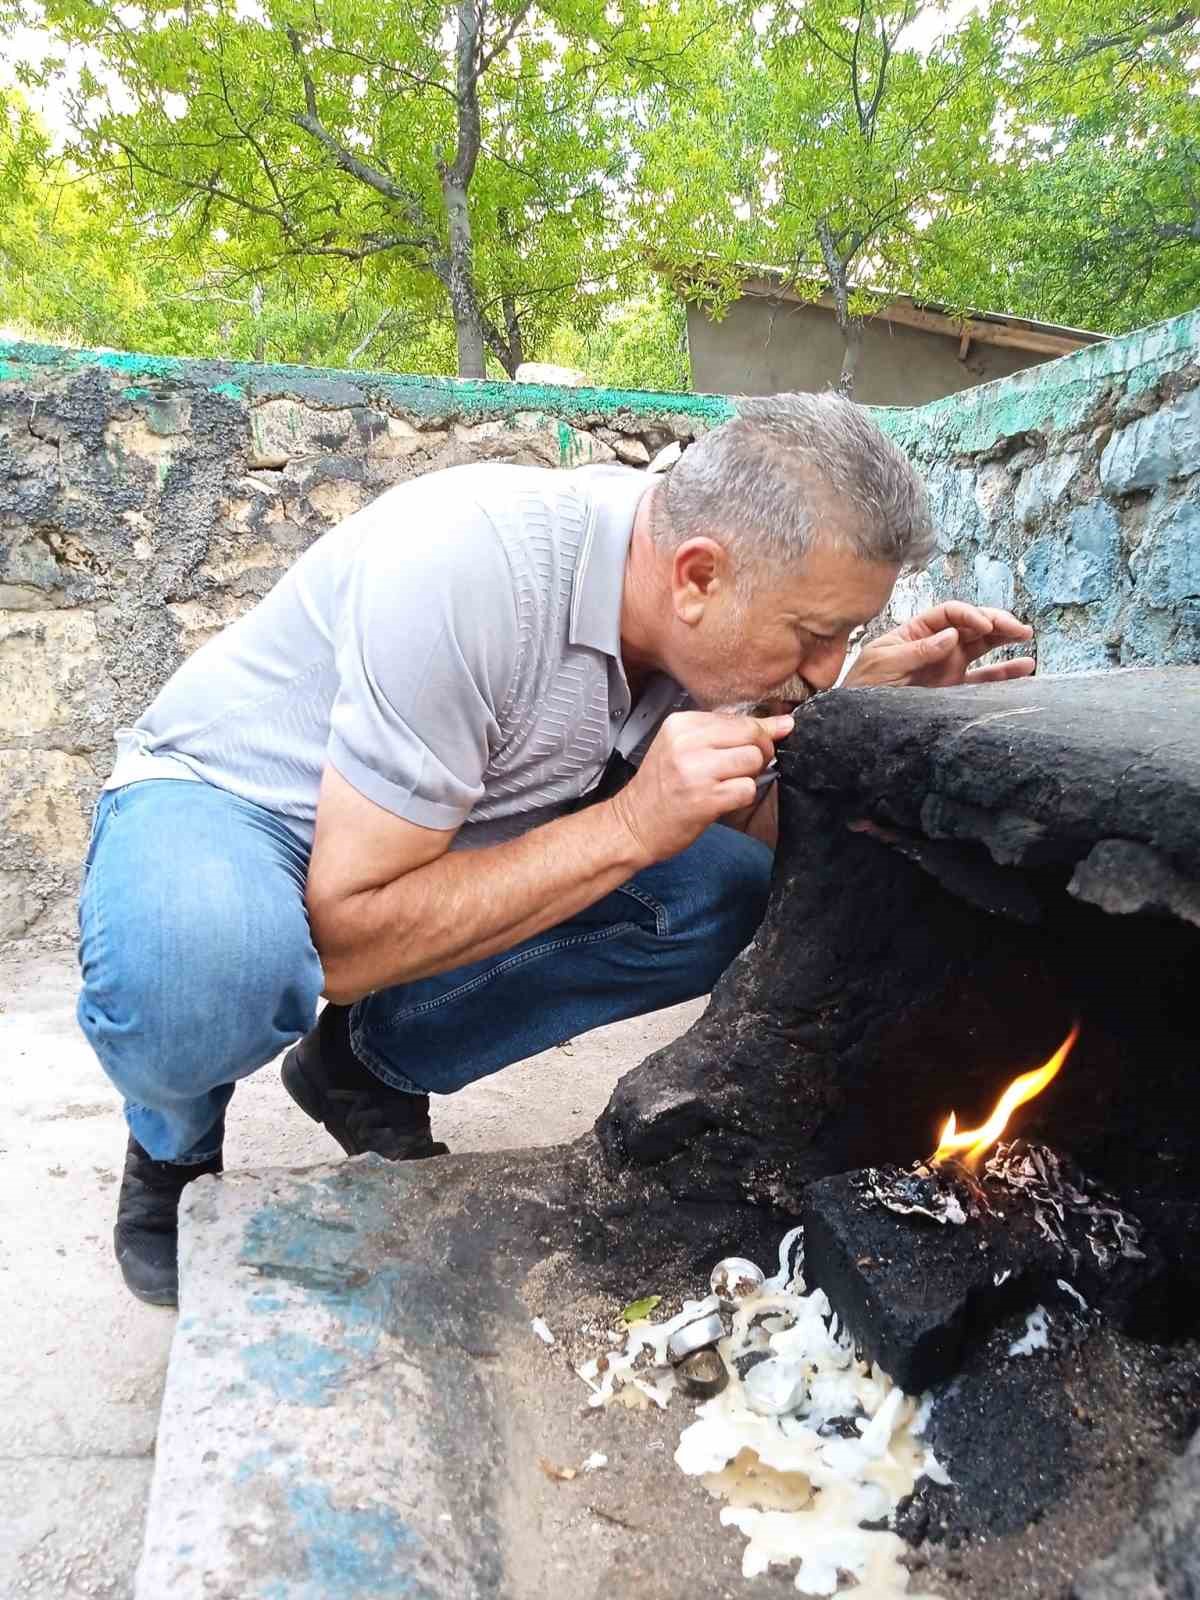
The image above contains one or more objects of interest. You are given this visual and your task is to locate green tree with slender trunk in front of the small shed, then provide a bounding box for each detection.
[637,0,1011,394]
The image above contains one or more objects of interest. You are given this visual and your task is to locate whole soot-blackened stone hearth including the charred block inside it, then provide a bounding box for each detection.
[598,669,1200,1597]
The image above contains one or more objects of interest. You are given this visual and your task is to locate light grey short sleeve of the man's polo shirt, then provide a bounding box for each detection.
[326,474,520,829]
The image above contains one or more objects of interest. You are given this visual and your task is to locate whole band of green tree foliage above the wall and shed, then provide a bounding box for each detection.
[0,0,1200,390]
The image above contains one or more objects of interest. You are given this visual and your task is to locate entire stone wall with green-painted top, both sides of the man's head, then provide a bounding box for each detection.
[0,317,1200,939]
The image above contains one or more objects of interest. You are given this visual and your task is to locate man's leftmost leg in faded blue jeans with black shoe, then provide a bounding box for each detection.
[77,779,323,1304]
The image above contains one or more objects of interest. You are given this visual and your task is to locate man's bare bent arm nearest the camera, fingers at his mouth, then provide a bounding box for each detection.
[307,712,792,1003]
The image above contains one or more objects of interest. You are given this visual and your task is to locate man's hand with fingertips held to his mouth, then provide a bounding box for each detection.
[610,710,795,861]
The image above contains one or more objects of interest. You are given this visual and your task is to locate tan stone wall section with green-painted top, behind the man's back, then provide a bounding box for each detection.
[0,342,731,939]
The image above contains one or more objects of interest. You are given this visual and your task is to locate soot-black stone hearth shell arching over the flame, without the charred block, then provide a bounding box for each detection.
[597,669,1200,1307]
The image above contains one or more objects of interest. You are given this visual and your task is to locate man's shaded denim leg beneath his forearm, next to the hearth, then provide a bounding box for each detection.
[349,826,771,1094]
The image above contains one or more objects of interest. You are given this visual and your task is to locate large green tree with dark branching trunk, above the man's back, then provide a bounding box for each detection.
[8,0,704,378]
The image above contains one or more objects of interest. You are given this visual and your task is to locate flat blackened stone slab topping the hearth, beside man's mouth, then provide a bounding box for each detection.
[779,667,1200,902]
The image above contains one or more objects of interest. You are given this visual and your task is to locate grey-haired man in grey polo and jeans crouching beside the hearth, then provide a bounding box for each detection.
[78,395,1032,1304]
